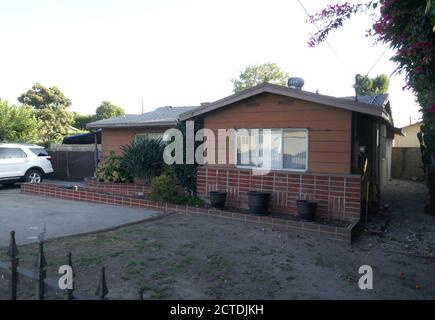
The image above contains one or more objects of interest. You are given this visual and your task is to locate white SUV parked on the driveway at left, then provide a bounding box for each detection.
[0,143,53,185]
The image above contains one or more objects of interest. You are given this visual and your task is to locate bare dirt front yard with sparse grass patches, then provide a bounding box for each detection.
[0,181,435,299]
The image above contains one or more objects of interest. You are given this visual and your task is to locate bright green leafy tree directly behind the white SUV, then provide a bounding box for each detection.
[0,99,41,143]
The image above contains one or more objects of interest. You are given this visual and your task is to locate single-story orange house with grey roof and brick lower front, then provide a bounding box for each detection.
[88,83,397,220]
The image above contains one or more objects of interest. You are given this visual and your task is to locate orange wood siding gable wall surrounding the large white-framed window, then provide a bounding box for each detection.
[204,94,352,174]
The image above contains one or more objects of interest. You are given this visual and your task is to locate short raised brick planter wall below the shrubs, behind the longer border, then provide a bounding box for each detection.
[85,178,151,196]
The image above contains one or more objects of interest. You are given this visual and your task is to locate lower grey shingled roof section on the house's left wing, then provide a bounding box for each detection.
[86,106,197,129]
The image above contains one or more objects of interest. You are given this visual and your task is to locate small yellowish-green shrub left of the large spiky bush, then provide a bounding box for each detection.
[95,151,132,182]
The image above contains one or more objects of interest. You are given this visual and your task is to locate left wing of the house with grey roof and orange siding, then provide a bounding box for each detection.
[86,107,195,156]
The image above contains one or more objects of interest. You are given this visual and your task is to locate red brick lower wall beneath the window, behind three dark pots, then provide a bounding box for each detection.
[197,166,361,220]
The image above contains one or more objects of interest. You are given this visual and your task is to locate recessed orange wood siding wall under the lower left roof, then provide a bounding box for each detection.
[101,128,168,157]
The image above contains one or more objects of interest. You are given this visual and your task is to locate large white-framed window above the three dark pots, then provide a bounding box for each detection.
[236,128,308,171]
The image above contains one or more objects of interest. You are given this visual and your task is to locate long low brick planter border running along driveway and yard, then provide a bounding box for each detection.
[21,183,358,243]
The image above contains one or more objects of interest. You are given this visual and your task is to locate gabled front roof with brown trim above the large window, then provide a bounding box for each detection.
[180,83,388,120]
